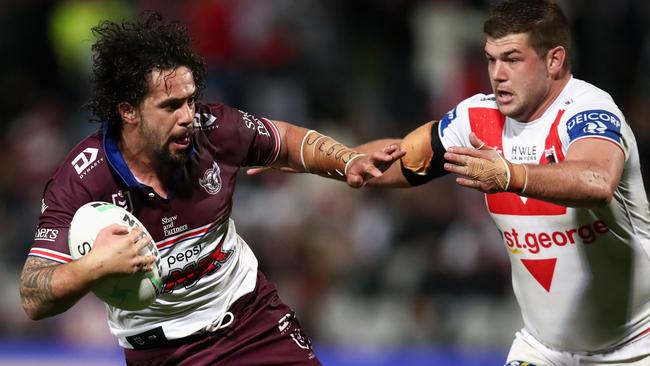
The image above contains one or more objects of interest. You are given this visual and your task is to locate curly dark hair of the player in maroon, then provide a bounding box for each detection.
[88,12,206,132]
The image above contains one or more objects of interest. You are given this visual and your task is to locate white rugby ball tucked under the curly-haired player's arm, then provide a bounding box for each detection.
[68,202,162,310]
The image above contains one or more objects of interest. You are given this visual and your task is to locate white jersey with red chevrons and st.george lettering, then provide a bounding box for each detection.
[434,78,650,352]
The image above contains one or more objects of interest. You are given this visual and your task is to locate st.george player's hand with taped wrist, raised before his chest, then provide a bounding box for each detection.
[444,132,510,193]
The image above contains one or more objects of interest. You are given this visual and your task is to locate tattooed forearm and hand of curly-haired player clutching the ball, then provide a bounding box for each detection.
[20,225,155,320]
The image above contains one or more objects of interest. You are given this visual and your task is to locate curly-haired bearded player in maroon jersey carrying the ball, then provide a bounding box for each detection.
[20,14,403,366]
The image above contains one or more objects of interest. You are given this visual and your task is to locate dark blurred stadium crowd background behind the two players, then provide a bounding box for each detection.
[0,0,650,366]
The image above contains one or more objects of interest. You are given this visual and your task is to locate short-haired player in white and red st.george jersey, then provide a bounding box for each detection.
[358,0,650,366]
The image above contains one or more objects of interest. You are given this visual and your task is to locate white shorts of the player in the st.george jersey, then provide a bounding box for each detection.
[506,329,650,366]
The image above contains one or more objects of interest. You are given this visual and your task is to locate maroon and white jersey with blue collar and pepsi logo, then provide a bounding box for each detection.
[29,104,281,348]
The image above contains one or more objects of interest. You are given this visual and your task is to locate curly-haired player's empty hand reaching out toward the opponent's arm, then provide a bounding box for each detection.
[346,145,406,188]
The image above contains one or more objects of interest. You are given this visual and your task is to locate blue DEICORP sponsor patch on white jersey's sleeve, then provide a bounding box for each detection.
[566,109,621,142]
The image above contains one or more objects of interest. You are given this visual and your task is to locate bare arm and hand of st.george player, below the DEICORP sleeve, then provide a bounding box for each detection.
[445,134,624,208]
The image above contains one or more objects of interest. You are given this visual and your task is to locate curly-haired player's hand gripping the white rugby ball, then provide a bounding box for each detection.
[80,224,155,279]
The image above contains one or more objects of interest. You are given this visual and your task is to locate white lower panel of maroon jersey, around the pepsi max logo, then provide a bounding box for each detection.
[106,219,258,348]
